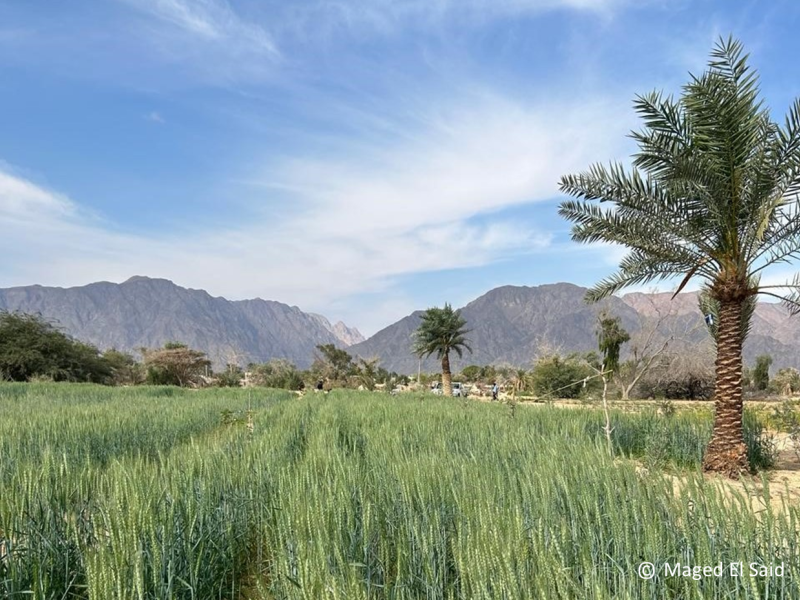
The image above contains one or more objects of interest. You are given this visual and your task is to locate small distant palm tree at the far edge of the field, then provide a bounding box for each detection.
[414,304,472,396]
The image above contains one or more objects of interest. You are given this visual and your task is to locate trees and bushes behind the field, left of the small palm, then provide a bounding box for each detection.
[0,311,409,390]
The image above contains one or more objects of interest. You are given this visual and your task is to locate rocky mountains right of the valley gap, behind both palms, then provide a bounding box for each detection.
[348,283,800,374]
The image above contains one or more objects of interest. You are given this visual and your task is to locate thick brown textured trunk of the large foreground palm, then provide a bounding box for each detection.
[703,299,750,477]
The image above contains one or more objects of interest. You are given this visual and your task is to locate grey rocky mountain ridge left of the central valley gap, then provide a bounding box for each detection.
[0,277,364,368]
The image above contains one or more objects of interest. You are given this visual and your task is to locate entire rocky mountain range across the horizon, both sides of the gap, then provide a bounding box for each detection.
[0,277,800,374]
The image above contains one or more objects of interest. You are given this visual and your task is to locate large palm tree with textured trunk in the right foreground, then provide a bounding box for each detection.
[559,38,800,476]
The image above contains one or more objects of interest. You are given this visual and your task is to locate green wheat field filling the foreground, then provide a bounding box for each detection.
[0,384,800,600]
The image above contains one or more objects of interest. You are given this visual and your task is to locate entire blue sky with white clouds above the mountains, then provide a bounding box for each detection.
[0,0,800,334]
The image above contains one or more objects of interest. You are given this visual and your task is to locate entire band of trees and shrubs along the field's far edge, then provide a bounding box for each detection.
[0,312,800,400]
